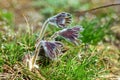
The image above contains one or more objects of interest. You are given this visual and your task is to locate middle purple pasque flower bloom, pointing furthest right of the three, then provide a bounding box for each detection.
[58,26,84,45]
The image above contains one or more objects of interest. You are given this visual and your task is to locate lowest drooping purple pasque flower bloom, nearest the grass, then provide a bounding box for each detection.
[40,41,63,59]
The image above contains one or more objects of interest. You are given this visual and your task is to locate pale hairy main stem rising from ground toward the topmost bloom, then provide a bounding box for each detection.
[32,19,49,68]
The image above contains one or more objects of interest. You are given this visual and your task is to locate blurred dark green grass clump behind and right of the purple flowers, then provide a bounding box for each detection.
[81,17,113,45]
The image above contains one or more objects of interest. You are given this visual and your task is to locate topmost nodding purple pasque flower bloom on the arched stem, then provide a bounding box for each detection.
[49,12,72,28]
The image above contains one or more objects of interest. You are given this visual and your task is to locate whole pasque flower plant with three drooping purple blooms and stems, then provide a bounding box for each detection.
[24,12,84,69]
